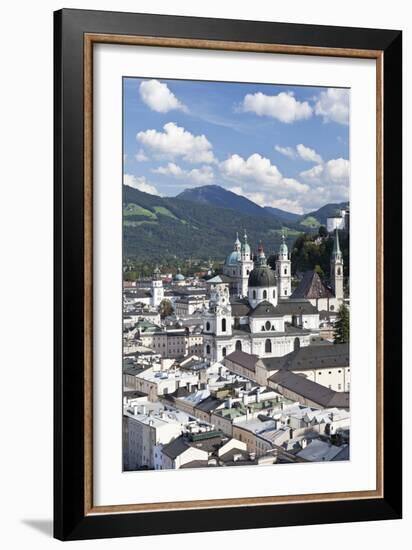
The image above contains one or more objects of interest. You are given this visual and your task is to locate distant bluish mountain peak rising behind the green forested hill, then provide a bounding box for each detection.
[176,185,266,216]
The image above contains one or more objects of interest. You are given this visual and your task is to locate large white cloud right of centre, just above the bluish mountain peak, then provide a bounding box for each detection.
[219,153,309,204]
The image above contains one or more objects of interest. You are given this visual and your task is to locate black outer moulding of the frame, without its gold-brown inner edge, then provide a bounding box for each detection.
[54,9,402,540]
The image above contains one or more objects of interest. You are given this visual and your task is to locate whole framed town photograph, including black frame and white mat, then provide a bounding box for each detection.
[54,9,402,540]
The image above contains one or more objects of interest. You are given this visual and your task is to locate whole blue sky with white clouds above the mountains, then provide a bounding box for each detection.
[123,77,350,214]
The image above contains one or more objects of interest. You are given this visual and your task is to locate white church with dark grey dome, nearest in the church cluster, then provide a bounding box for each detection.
[202,242,319,362]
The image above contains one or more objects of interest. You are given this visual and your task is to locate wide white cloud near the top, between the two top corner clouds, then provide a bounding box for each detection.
[242,92,312,124]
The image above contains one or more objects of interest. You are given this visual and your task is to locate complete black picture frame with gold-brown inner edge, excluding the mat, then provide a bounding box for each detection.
[54,9,402,540]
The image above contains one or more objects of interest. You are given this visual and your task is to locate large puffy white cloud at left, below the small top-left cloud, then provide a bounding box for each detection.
[136,122,216,164]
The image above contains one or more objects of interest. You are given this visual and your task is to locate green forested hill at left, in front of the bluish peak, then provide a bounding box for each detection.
[123,185,299,261]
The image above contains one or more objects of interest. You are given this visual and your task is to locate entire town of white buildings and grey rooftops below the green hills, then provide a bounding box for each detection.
[123,229,351,471]
